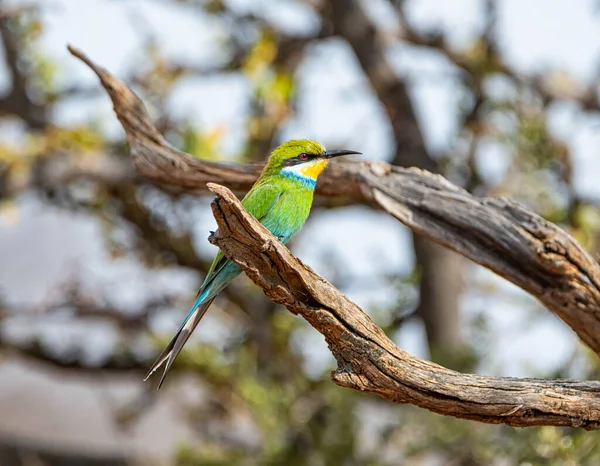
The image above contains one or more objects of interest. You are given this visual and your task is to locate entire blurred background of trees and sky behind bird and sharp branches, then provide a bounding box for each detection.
[0,0,600,466]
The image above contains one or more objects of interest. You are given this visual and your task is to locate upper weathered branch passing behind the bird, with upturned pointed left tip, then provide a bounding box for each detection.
[69,47,600,354]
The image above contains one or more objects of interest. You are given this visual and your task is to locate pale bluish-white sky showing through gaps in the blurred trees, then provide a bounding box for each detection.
[0,0,600,458]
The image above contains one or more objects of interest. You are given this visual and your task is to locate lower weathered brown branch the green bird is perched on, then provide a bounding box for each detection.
[209,183,600,430]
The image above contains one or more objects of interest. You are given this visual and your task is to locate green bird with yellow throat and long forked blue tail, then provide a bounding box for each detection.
[144,139,361,389]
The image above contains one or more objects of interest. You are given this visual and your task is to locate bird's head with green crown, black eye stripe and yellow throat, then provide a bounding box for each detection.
[265,139,360,185]
